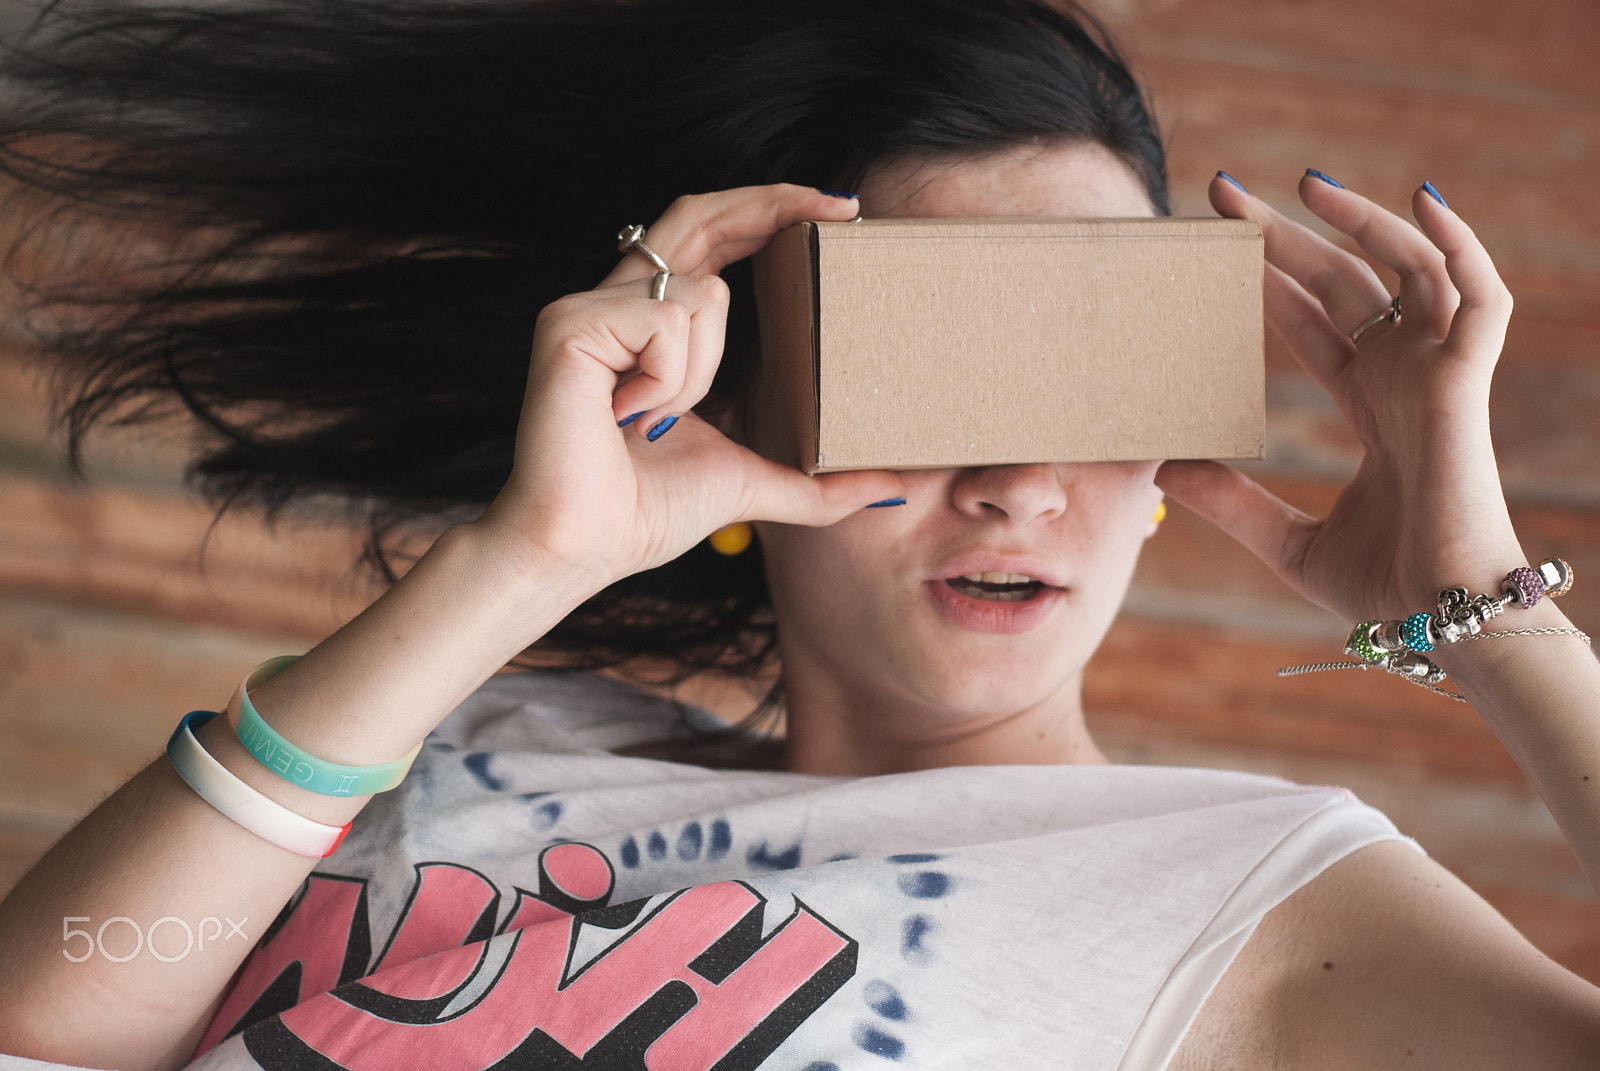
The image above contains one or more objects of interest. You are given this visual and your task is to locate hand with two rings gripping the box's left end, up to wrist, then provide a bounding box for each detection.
[477,186,904,586]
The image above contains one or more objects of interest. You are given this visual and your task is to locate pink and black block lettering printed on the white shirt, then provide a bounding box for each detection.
[202,844,858,1071]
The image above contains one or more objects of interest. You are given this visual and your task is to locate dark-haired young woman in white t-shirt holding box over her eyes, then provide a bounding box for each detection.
[0,0,1600,1071]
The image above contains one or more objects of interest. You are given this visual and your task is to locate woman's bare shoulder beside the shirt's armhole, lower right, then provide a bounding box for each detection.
[1170,842,1600,1071]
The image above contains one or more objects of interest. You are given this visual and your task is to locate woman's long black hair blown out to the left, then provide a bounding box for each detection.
[0,0,1168,677]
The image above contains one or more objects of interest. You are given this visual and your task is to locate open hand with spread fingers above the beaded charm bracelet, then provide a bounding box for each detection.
[1157,173,1525,621]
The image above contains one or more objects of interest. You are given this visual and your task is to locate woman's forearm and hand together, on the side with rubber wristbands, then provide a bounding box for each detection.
[0,186,902,1068]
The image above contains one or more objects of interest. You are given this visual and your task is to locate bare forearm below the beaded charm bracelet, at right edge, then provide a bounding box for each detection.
[1429,599,1600,890]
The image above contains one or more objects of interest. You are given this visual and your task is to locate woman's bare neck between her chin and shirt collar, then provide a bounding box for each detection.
[784,640,1109,776]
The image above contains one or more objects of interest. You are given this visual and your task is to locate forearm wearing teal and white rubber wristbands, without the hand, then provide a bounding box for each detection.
[0,528,595,1068]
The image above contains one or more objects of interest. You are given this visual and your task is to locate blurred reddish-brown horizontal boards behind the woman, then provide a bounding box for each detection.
[0,0,1600,983]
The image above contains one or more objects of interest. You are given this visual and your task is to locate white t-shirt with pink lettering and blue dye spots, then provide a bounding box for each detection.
[9,672,1405,1071]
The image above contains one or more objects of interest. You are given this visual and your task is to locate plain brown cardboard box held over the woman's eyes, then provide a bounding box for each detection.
[750,218,1266,472]
